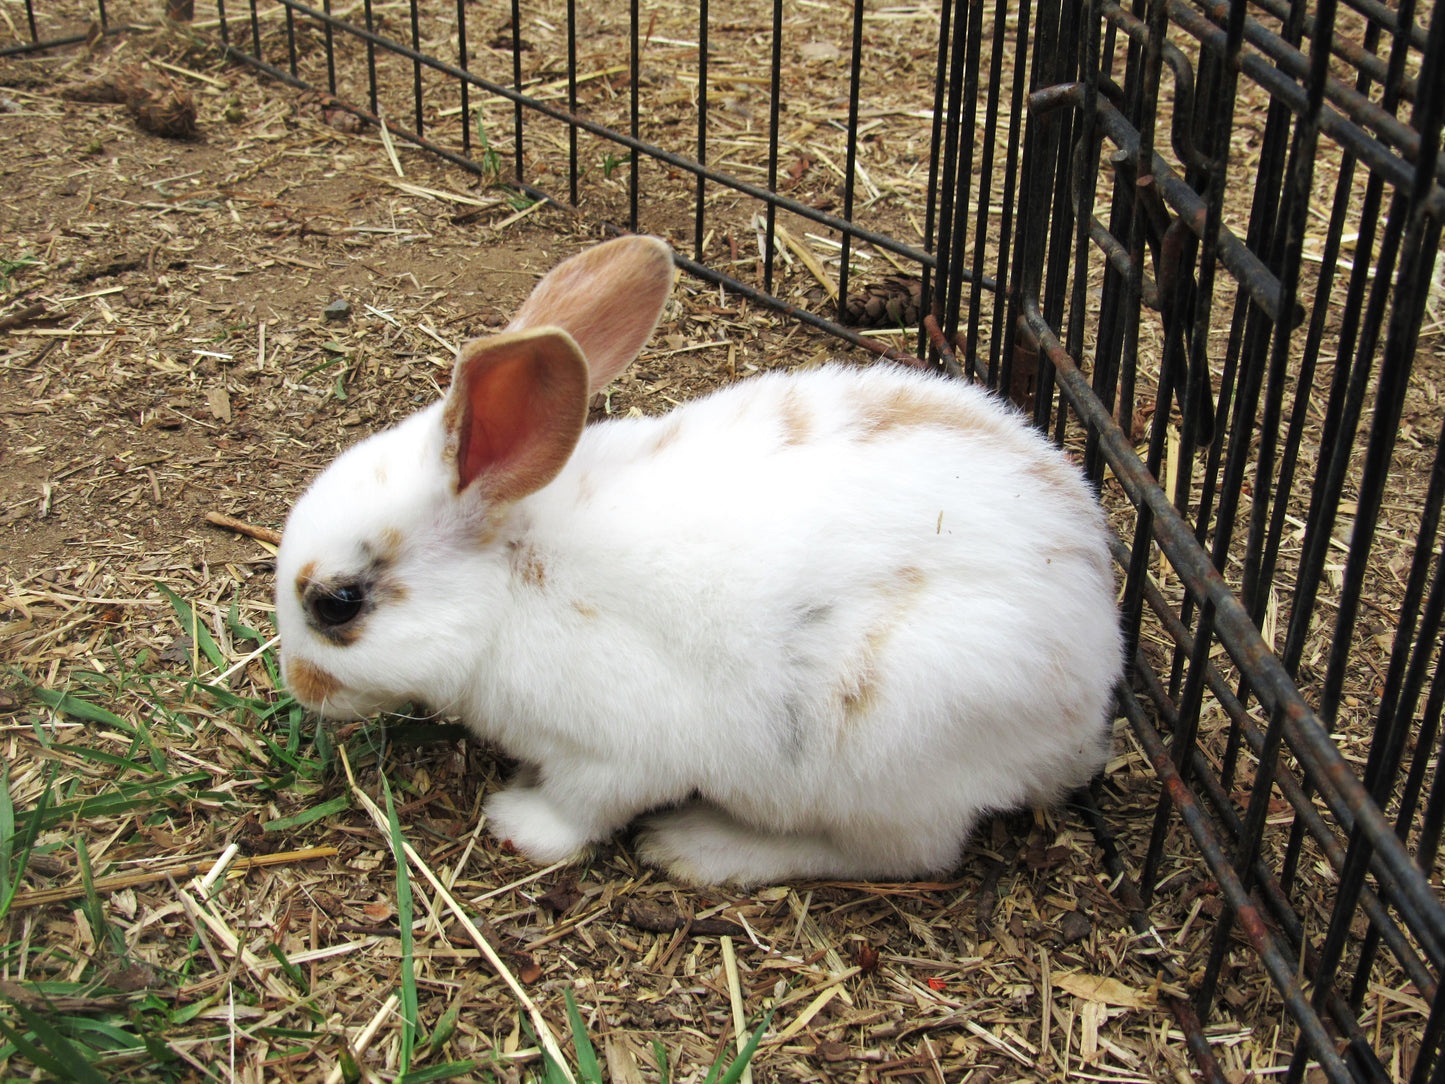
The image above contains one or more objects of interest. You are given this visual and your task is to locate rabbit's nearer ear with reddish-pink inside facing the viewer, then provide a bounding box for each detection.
[442,327,588,500]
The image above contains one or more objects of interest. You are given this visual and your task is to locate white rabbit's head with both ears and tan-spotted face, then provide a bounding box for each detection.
[276,237,672,718]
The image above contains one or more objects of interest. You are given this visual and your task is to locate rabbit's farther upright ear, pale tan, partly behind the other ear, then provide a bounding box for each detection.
[509,234,672,392]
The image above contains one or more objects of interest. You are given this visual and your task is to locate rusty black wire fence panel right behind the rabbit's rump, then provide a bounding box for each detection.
[996,1,1445,1081]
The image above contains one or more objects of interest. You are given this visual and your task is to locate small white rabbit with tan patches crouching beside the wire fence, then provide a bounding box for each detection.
[276,236,1123,886]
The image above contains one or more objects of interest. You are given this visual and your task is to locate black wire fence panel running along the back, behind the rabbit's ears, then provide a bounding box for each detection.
[183,0,971,370]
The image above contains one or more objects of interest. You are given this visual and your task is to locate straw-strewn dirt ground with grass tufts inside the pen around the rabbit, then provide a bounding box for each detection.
[0,6,1433,1081]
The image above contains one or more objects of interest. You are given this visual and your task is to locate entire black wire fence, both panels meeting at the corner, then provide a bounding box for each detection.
[12,0,1445,1083]
